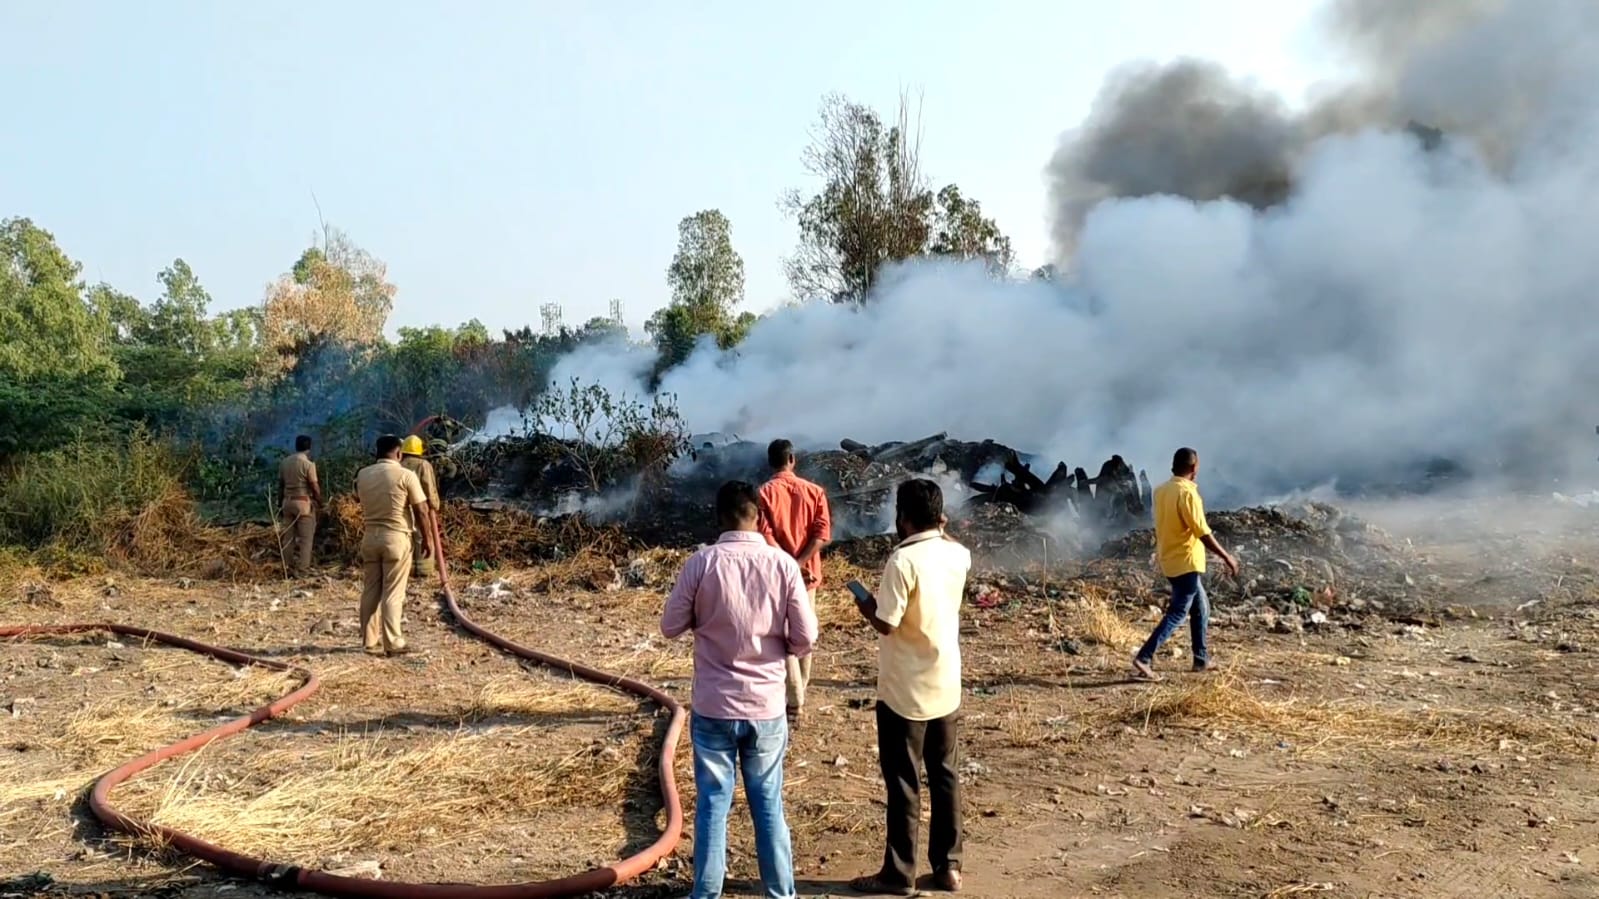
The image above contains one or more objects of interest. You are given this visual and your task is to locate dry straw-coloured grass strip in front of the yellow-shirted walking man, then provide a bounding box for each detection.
[1110,669,1599,758]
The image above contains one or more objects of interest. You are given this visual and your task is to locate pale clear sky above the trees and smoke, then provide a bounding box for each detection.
[0,0,1337,331]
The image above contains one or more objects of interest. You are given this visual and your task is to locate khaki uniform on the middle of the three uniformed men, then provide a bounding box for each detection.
[355,459,427,653]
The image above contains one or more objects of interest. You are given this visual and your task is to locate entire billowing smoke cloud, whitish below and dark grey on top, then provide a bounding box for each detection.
[556,0,1599,501]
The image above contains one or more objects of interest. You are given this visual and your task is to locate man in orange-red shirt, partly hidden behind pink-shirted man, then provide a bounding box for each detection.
[761,440,833,717]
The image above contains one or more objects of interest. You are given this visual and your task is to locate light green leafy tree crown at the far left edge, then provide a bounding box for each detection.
[0,218,118,382]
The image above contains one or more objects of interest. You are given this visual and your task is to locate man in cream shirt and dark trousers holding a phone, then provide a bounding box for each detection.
[851,478,972,896]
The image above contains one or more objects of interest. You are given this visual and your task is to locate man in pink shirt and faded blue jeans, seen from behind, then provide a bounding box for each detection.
[660,481,817,899]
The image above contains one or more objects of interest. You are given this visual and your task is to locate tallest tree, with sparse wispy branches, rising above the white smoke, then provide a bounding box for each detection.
[784,94,1012,302]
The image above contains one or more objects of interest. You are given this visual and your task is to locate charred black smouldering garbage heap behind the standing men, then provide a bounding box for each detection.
[424,419,1150,561]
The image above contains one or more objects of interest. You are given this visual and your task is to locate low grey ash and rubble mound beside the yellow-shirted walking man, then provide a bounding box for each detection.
[1099,502,1436,630]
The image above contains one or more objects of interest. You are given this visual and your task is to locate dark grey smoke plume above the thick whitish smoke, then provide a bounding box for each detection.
[1047,0,1599,256]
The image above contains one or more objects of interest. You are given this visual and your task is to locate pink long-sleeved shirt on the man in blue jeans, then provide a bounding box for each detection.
[660,531,817,721]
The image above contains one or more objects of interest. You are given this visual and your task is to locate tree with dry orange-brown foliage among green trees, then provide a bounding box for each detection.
[261,226,397,365]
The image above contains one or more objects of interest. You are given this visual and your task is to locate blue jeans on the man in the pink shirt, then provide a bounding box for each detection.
[689,715,795,899]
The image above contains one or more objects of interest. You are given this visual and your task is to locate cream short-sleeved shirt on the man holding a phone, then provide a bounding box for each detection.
[876,531,972,721]
